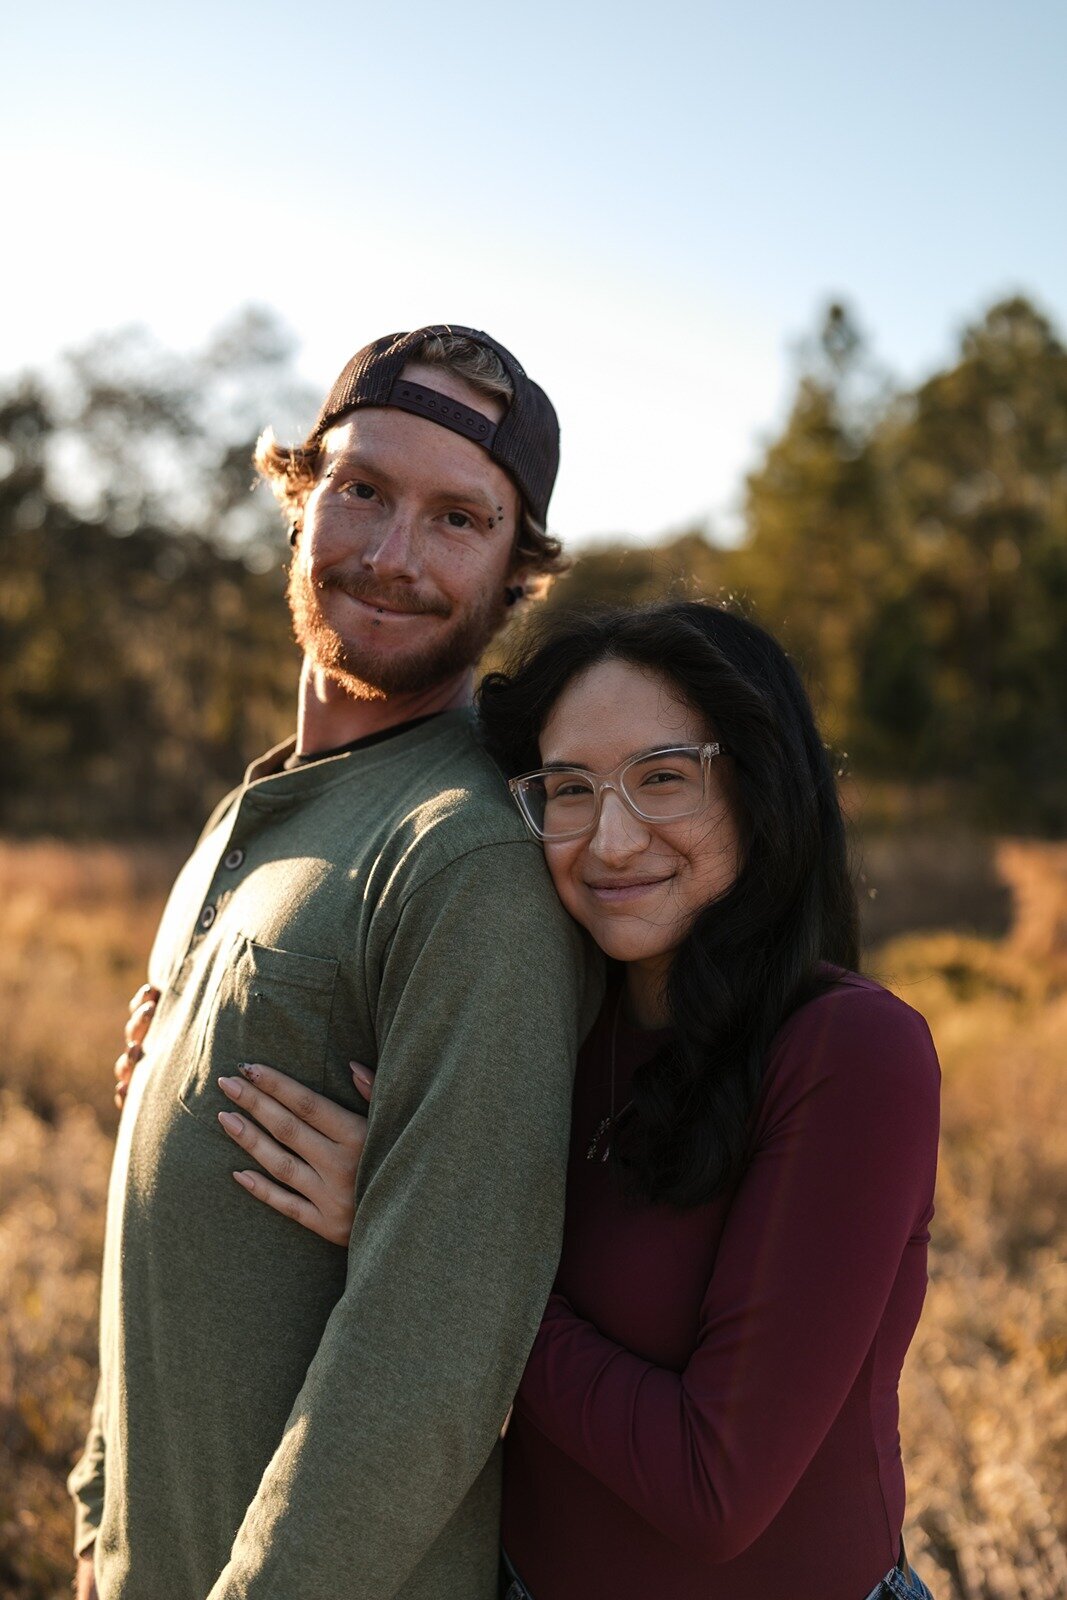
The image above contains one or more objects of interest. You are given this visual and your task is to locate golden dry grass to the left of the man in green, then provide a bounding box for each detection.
[0,842,173,1600]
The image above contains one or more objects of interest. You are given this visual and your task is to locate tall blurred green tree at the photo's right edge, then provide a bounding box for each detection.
[856,298,1067,827]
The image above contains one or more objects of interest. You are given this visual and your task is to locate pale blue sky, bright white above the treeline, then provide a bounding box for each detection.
[8,0,1067,546]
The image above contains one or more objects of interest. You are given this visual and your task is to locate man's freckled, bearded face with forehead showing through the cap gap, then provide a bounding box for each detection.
[288,363,520,699]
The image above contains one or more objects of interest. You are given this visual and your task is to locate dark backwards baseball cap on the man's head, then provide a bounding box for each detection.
[310,322,560,523]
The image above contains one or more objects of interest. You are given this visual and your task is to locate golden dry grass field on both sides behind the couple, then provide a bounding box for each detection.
[0,843,1067,1600]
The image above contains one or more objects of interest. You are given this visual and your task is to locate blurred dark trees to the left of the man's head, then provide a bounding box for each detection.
[0,312,307,832]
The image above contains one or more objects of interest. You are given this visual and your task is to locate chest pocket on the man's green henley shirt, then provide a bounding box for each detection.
[178,934,338,1122]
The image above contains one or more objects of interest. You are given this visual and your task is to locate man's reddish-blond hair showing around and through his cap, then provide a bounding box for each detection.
[253,333,571,598]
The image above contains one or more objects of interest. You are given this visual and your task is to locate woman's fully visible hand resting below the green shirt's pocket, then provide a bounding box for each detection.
[219,1061,374,1245]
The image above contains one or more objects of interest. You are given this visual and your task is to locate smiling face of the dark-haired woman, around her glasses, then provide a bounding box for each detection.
[541,661,739,976]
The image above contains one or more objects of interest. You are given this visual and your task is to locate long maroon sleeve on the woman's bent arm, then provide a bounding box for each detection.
[517,987,939,1562]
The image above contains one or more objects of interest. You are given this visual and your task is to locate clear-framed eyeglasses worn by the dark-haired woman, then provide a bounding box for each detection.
[507,744,725,843]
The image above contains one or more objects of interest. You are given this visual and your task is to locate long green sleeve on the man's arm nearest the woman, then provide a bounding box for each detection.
[204,843,597,1600]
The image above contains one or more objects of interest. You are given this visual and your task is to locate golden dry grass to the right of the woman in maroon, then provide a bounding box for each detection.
[880,934,1067,1600]
